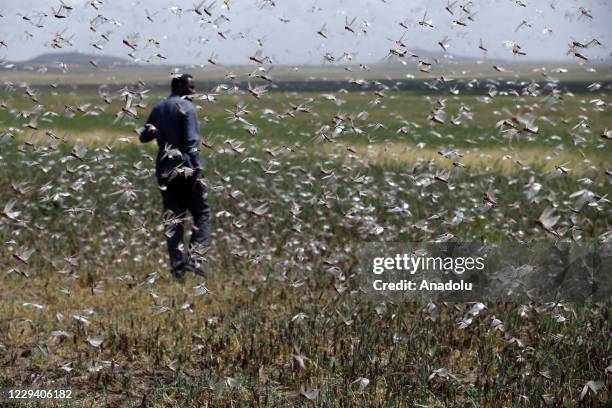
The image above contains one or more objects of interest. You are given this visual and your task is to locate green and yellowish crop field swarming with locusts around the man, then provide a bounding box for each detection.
[0,68,612,407]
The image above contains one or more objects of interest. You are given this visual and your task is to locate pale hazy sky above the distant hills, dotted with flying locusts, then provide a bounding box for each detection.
[0,0,612,65]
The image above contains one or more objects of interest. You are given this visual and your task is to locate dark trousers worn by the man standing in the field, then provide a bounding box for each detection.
[161,176,211,267]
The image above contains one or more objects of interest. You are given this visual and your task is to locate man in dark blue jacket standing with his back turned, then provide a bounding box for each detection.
[139,74,211,280]
